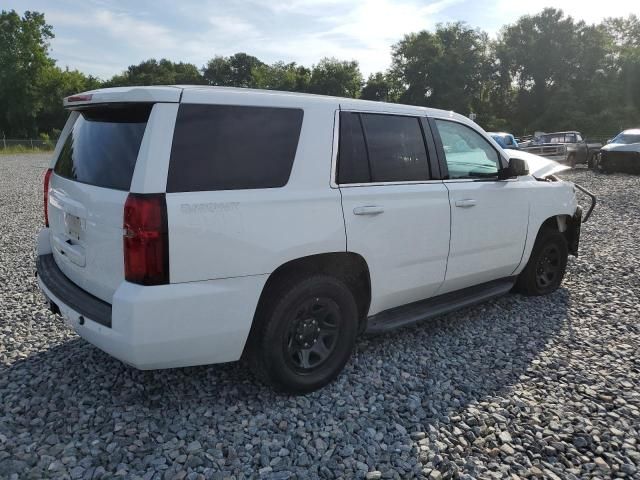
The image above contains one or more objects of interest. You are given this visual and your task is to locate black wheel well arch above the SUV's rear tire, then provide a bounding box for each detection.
[249,252,371,344]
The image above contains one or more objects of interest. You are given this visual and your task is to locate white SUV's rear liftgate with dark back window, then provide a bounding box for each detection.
[49,103,154,302]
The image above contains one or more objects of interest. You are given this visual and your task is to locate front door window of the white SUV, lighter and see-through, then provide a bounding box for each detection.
[435,120,500,178]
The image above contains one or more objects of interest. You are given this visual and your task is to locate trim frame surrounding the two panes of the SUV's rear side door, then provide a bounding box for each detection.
[330,107,442,188]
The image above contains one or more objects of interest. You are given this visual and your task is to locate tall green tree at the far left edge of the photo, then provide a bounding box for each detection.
[0,10,54,137]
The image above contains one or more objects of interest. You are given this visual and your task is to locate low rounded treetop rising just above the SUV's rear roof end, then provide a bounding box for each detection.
[104,58,206,87]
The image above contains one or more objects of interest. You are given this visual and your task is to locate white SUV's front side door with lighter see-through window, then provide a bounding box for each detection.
[431,119,530,293]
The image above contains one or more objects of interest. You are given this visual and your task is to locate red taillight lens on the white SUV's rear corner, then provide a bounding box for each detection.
[124,193,169,285]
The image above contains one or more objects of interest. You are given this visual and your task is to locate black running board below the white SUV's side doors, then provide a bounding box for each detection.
[365,277,516,334]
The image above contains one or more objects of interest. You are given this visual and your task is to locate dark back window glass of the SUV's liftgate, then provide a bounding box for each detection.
[54,104,153,190]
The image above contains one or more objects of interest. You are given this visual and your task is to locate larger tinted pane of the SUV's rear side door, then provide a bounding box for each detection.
[361,113,429,182]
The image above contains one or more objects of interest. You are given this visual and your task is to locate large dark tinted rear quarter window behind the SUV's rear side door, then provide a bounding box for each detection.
[167,104,303,192]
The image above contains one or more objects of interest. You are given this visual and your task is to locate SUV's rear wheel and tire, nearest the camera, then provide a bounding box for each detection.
[247,275,358,394]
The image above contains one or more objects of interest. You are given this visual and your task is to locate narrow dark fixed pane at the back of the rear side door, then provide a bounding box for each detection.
[338,112,371,183]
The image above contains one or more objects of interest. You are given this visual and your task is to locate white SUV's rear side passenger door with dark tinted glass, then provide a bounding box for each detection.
[334,111,450,315]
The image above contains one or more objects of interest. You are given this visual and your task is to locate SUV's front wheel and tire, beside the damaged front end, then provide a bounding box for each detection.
[514,228,569,296]
